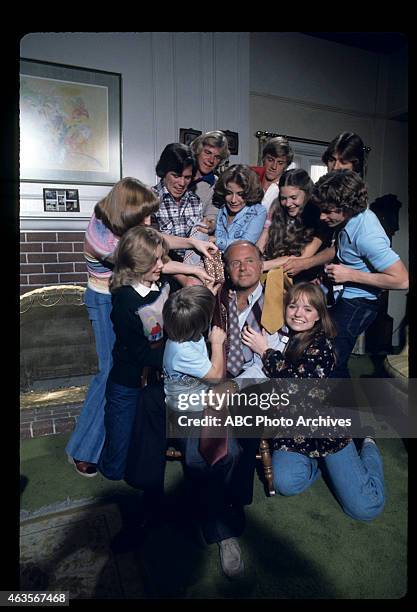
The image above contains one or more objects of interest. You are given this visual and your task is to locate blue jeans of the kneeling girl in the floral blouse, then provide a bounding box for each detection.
[272,442,385,521]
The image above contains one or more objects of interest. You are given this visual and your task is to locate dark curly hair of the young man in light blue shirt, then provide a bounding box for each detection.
[311,170,368,218]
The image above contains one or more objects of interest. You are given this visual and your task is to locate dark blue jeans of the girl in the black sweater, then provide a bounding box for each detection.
[97,380,140,480]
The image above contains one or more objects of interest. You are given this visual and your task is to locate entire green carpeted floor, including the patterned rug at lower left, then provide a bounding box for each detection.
[21,435,407,599]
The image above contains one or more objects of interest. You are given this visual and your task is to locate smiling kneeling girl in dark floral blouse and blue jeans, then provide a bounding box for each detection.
[242,283,385,521]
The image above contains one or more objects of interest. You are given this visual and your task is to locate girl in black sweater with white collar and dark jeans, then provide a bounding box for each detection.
[98,226,169,480]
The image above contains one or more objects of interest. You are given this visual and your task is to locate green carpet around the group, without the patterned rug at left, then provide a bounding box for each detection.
[21,435,407,599]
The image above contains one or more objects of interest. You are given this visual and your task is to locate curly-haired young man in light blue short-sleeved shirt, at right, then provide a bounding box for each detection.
[313,170,408,378]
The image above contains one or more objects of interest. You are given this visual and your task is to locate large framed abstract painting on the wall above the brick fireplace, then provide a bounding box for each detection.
[20,59,122,185]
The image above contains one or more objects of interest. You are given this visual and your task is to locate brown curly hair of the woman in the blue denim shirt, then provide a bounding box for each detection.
[213,164,264,207]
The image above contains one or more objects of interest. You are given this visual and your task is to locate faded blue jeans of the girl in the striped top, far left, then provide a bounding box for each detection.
[65,288,115,463]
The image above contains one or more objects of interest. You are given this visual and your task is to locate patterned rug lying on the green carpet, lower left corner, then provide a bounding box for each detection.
[20,506,125,599]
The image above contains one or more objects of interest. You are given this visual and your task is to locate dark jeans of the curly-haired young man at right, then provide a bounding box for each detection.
[329,297,379,378]
